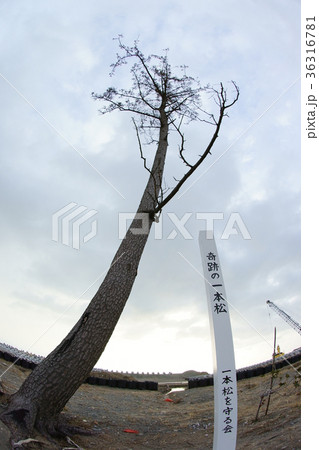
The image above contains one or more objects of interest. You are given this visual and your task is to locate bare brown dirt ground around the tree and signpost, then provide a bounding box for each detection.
[0,360,301,450]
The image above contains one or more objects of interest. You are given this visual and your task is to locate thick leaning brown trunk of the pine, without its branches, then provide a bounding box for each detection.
[1,113,168,436]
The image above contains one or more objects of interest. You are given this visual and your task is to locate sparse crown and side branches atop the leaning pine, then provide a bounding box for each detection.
[92,35,239,213]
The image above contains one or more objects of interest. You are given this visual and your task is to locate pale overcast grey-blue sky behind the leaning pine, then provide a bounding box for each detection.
[0,0,300,372]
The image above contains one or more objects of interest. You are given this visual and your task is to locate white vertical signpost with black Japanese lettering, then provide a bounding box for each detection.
[199,231,237,450]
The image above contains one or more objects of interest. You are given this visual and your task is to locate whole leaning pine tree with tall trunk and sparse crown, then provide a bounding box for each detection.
[1,37,239,439]
